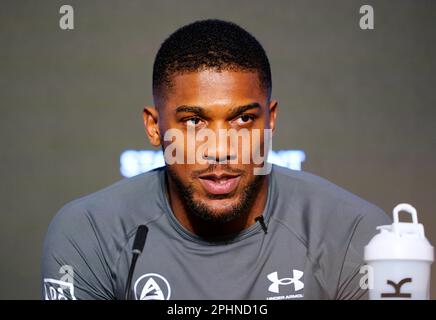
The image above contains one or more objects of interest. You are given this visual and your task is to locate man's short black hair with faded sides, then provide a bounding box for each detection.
[153,19,272,98]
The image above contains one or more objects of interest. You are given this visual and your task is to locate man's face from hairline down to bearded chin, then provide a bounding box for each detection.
[146,69,276,222]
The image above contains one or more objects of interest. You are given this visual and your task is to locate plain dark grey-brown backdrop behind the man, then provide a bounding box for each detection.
[0,0,436,299]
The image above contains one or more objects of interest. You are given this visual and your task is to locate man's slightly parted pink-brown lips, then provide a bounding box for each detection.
[198,173,241,195]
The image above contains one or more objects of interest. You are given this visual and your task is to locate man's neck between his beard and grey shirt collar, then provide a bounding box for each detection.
[166,175,269,238]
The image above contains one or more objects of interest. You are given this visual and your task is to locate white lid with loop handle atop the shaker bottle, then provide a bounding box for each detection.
[364,203,434,262]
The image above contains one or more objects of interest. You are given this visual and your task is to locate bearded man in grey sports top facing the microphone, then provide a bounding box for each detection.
[42,20,389,300]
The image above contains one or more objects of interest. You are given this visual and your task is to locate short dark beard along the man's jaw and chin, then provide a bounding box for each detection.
[167,166,264,224]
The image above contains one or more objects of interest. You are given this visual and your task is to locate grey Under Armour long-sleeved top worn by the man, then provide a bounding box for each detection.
[42,166,391,300]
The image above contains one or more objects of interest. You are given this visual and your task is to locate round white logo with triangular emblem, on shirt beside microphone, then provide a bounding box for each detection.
[134,273,171,300]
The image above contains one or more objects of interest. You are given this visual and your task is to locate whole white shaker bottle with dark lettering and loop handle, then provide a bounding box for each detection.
[365,203,434,300]
